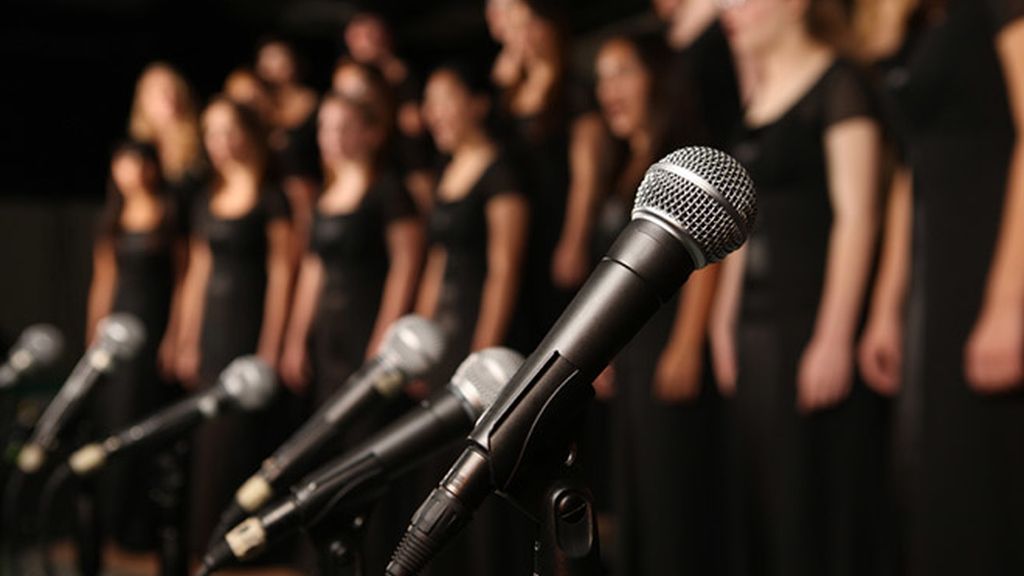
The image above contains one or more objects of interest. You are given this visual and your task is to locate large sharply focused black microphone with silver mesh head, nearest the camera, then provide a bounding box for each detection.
[387,148,757,576]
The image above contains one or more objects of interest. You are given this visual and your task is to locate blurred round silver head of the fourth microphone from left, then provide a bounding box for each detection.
[377,315,444,378]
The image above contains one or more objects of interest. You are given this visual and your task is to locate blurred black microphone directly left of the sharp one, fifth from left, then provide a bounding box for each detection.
[201,348,522,574]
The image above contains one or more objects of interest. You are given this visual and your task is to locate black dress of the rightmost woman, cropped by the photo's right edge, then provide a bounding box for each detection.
[886,0,1024,576]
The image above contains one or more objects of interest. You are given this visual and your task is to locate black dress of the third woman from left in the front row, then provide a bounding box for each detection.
[309,174,416,406]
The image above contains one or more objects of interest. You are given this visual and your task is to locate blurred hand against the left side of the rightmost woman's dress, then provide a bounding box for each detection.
[858,314,903,396]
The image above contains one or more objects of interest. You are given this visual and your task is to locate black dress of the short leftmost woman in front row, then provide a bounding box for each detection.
[96,218,175,549]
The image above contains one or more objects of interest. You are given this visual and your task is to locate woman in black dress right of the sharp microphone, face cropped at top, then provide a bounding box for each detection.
[713,0,886,576]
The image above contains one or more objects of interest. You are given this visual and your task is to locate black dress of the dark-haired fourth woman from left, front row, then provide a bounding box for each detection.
[420,153,536,576]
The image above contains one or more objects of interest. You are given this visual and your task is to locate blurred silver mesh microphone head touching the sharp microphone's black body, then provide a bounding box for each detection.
[449,347,523,421]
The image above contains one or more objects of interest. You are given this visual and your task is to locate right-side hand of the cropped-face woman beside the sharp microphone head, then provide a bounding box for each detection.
[797,335,853,413]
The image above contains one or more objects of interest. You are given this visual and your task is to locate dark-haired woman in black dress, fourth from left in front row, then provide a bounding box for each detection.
[417,62,532,576]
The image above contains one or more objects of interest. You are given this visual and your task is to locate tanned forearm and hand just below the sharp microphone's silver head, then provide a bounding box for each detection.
[654,265,720,403]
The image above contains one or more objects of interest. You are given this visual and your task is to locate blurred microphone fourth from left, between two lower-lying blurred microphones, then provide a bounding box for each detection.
[221,316,444,528]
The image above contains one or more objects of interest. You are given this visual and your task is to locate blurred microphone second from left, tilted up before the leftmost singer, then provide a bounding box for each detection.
[17,313,145,474]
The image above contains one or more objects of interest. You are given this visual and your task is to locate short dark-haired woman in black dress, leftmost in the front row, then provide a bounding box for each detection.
[87,141,184,551]
